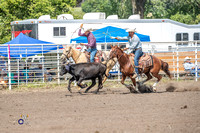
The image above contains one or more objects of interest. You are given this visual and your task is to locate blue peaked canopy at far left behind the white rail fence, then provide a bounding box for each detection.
[0,33,62,59]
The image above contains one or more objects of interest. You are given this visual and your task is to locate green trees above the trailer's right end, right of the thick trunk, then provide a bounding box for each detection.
[144,0,200,24]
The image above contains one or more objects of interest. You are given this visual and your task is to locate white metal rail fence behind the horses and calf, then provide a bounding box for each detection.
[0,41,200,90]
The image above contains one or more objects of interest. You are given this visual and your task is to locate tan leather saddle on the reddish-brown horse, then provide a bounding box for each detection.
[130,53,153,68]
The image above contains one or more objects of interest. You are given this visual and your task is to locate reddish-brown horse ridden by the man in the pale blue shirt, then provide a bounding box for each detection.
[110,46,171,92]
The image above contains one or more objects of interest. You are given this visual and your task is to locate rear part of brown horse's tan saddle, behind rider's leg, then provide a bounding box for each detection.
[139,53,153,68]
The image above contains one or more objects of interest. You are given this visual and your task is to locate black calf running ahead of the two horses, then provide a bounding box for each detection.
[60,63,106,93]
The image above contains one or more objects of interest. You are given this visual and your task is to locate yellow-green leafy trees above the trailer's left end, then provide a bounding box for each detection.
[0,0,76,44]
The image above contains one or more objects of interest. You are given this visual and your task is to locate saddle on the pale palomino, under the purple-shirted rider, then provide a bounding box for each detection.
[84,50,107,62]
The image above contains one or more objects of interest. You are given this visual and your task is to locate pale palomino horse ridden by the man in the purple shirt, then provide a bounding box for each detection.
[60,46,117,83]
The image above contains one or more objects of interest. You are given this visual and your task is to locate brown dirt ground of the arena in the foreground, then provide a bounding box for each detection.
[0,82,200,133]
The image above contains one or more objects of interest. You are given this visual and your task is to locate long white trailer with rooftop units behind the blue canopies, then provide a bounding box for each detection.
[11,13,200,51]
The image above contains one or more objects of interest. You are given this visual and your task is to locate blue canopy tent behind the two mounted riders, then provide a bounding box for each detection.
[71,26,150,43]
